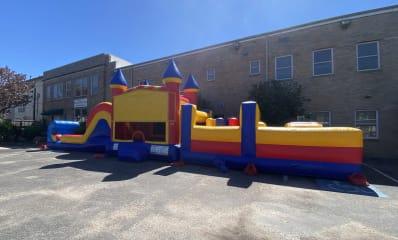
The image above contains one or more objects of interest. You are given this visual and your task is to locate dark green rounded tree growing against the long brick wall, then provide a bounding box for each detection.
[249,81,304,125]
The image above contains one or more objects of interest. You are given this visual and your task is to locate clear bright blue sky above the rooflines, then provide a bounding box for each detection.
[0,0,398,77]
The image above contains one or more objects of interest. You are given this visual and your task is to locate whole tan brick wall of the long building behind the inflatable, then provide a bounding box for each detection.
[125,9,398,158]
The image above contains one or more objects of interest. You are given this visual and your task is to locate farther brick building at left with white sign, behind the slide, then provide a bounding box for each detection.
[42,54,130,120]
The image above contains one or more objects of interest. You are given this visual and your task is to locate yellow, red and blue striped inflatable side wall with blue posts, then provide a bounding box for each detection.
[181,101,362,179]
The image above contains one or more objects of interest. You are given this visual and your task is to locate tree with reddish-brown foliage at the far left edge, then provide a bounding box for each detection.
[0,67,31,116]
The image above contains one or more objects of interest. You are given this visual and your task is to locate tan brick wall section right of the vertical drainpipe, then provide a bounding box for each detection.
[269,13,398,158]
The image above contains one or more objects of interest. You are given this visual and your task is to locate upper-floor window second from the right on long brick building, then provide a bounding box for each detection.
[312,48,333,76]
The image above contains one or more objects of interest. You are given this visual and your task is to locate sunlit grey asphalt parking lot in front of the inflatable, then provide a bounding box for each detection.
[0,147,398,239]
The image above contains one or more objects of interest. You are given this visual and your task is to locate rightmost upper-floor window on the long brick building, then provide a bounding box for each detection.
[357,42,380,71]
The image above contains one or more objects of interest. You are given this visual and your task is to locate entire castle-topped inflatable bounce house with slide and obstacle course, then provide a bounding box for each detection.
[47,60,363,182]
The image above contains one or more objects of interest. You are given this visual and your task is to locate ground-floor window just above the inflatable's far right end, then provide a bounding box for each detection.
[355,110,379,139]
